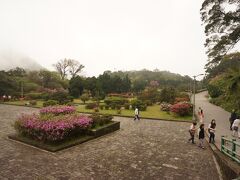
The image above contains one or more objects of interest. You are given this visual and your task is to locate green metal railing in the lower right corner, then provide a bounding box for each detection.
[221,136,240,163]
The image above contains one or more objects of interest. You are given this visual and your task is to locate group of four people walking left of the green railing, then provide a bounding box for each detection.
[188,107,216,149]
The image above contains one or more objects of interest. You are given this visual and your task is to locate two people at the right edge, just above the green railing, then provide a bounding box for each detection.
[229,109,240,138]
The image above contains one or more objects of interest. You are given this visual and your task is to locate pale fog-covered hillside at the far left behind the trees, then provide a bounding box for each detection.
[0,51,43,70]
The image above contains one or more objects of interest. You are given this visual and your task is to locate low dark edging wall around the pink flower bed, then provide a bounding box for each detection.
[8,121,120,152]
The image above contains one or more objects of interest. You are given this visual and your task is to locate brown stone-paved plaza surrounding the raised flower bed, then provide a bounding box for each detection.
[0,105,219,180]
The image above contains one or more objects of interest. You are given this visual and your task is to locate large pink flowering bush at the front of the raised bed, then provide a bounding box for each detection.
[14,112,92,142]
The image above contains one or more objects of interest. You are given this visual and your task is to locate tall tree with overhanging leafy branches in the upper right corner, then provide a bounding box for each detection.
[201,0,240,69]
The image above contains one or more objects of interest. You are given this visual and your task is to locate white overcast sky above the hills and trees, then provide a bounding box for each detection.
[0,0,207,76]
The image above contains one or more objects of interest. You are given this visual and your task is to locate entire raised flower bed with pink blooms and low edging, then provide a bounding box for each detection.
[8,106,120,152]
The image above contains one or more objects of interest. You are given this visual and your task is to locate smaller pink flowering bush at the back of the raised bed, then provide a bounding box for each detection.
[40,106,76,116]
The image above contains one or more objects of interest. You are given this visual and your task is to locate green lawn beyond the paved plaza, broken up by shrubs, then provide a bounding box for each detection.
[2,100,192,121]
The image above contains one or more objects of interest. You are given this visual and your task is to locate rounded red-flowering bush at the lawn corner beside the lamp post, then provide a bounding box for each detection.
[171,103,192,116]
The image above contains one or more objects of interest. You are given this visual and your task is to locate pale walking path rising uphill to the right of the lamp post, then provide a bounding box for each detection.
[195,91,240,149]
